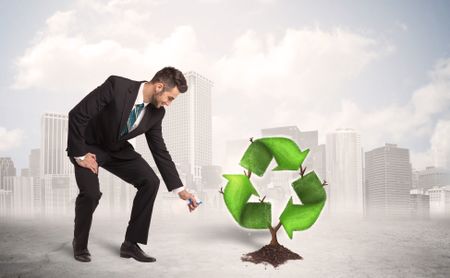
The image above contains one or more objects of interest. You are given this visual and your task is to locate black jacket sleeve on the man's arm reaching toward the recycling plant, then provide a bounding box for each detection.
[145,109,183,191]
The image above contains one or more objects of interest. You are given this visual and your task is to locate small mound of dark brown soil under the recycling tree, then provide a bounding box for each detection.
[241,244,303,267]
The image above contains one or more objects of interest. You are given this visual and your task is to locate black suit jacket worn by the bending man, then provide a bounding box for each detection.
[66,76,183,191]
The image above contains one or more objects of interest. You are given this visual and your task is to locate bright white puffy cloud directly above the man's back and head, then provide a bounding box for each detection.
[13,23,206,92]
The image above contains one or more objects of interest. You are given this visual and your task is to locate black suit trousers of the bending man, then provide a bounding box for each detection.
[70,145,160,249]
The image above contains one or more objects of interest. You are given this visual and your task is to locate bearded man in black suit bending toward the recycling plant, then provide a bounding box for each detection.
[66,67,198,262]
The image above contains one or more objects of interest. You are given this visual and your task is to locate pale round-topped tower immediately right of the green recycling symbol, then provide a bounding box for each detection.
[326,129,364,217]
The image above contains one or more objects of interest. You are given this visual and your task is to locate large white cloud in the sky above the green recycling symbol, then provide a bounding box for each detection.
[215,28,379,100]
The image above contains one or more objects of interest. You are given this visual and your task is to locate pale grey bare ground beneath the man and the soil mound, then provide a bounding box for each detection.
[0,203,450,277]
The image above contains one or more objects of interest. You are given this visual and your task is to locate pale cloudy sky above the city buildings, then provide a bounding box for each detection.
[0,0,450,170]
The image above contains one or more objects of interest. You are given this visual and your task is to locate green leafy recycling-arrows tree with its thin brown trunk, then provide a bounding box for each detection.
[220,137,327,250]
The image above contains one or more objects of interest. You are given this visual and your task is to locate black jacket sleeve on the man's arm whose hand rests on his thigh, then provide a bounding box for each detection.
[67,76,113,156]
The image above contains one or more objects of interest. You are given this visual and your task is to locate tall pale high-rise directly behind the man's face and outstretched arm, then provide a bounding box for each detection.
[136,71,213,189]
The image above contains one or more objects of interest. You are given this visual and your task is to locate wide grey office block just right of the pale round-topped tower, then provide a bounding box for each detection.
[365,144,412,217]
